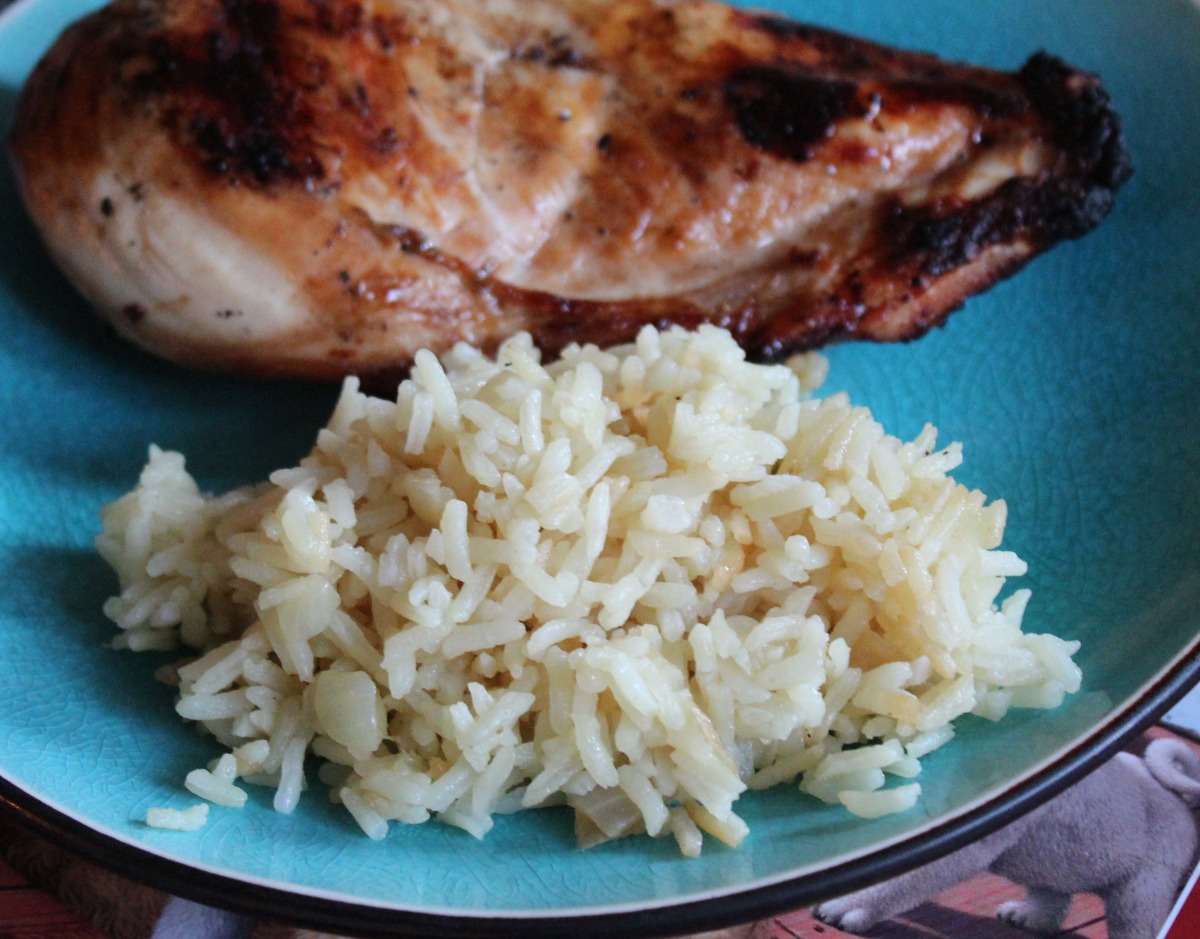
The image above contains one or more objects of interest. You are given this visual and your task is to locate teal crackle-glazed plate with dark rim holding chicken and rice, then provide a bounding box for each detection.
[0,0,1200,937]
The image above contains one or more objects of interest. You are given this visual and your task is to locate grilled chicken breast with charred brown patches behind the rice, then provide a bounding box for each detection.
[12,0,1129,378]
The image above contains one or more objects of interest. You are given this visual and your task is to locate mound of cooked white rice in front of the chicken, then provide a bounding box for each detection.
[97,328,1080,855]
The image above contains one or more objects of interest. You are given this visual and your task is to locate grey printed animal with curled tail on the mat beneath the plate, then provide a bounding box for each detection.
[814,738,1200,939]
